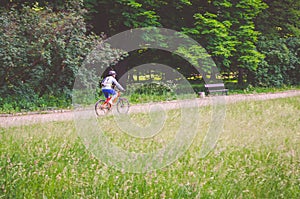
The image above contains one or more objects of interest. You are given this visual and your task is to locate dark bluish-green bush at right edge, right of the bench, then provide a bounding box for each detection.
[254,37,300,87]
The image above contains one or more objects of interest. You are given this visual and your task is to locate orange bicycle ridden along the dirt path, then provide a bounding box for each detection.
[95,91,130,116]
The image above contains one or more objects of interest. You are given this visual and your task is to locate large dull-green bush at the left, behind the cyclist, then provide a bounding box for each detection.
[0,1,125,111]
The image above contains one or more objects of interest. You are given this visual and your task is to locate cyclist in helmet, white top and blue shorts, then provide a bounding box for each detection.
[101,70,125,108]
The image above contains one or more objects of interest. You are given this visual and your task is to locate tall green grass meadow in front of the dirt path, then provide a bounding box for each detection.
[0,96,300,199]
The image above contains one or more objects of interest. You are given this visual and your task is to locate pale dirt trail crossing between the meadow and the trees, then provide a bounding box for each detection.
[0,90,300,127]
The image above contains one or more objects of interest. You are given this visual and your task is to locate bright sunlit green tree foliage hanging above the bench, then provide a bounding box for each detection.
[178,0,267,84]
